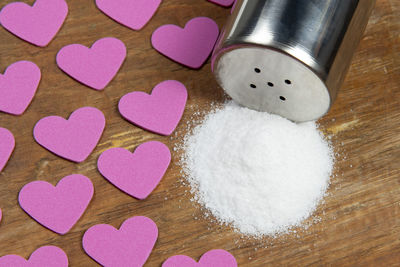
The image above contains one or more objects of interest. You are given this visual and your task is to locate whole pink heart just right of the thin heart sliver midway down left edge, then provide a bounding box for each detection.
[33,107,106,162]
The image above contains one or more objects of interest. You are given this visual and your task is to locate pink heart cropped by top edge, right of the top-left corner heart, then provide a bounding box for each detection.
[96,0,161,30]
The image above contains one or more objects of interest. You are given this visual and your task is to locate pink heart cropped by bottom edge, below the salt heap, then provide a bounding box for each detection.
[162,249,237,267]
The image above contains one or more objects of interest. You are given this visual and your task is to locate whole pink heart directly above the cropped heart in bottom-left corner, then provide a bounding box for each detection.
[18,174,94,235]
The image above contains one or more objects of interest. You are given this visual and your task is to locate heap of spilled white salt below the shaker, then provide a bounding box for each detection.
[181,103,333,237]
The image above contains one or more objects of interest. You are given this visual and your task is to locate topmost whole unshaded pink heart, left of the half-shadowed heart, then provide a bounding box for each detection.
[56,37,126,90]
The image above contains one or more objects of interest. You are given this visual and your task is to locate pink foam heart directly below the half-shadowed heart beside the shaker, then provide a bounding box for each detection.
[118,80,187,135]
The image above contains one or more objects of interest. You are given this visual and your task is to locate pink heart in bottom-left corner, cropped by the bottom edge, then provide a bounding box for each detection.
[0,246,68,267]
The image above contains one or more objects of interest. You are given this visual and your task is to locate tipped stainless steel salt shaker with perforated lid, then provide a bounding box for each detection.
[212,0,375,122]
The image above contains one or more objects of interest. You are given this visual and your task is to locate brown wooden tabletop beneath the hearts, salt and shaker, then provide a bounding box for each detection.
[0,0,400,266]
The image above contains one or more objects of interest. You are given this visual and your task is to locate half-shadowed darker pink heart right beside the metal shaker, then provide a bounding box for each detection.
[151,17,219,69]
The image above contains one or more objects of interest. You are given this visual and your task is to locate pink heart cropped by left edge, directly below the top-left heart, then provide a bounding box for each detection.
[0,61,41,115]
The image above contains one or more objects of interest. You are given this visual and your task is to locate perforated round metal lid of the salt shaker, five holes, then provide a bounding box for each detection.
[215,47,331,122]
